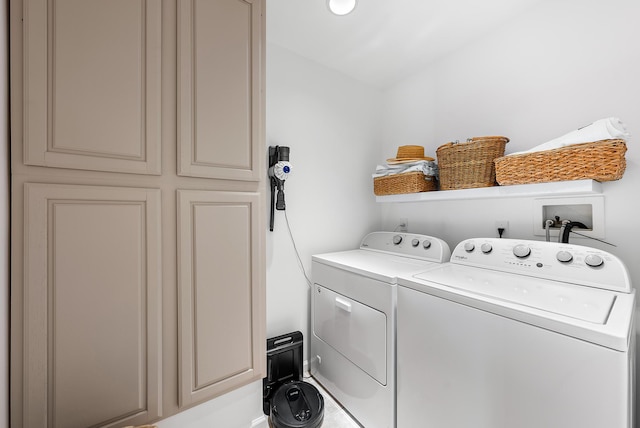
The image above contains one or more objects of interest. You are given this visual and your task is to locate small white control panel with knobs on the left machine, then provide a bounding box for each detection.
[360,232,451,263]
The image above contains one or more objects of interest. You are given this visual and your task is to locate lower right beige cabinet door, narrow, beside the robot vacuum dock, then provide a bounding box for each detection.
[177,190,266,407]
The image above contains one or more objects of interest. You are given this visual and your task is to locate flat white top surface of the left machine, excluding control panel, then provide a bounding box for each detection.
[312,250,440,284]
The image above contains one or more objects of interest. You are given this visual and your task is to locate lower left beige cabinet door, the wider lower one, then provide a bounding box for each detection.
[23,183,162,428]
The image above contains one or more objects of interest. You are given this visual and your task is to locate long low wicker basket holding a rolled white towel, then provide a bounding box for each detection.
[495,140,627,185]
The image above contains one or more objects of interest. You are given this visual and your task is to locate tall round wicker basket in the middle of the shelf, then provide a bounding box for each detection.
[436,136,509,190]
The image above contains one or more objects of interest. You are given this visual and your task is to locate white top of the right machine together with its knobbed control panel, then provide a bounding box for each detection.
[398,238,635,350]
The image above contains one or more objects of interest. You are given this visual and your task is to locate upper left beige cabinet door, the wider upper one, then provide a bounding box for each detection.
[23,0,162,174]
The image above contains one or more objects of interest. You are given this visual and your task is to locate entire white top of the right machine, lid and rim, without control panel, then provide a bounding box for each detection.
[398,263,635,352]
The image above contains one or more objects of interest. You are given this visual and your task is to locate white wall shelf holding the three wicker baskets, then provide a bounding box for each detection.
[376,180,602,202]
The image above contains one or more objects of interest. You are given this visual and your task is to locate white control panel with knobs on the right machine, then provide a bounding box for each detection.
[451,238,631,293]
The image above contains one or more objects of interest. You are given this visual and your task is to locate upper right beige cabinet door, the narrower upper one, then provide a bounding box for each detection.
[178,0,265,181]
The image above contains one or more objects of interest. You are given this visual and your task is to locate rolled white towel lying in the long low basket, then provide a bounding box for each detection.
[507,117,629,156]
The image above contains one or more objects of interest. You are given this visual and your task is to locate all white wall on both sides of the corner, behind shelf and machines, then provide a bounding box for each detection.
[267,6,640,428]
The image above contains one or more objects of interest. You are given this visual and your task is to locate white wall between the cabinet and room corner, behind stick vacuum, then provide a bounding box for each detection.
[266,44,382,354]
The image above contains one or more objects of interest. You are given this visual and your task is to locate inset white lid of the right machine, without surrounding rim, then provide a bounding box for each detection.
[415,264,615,324]
